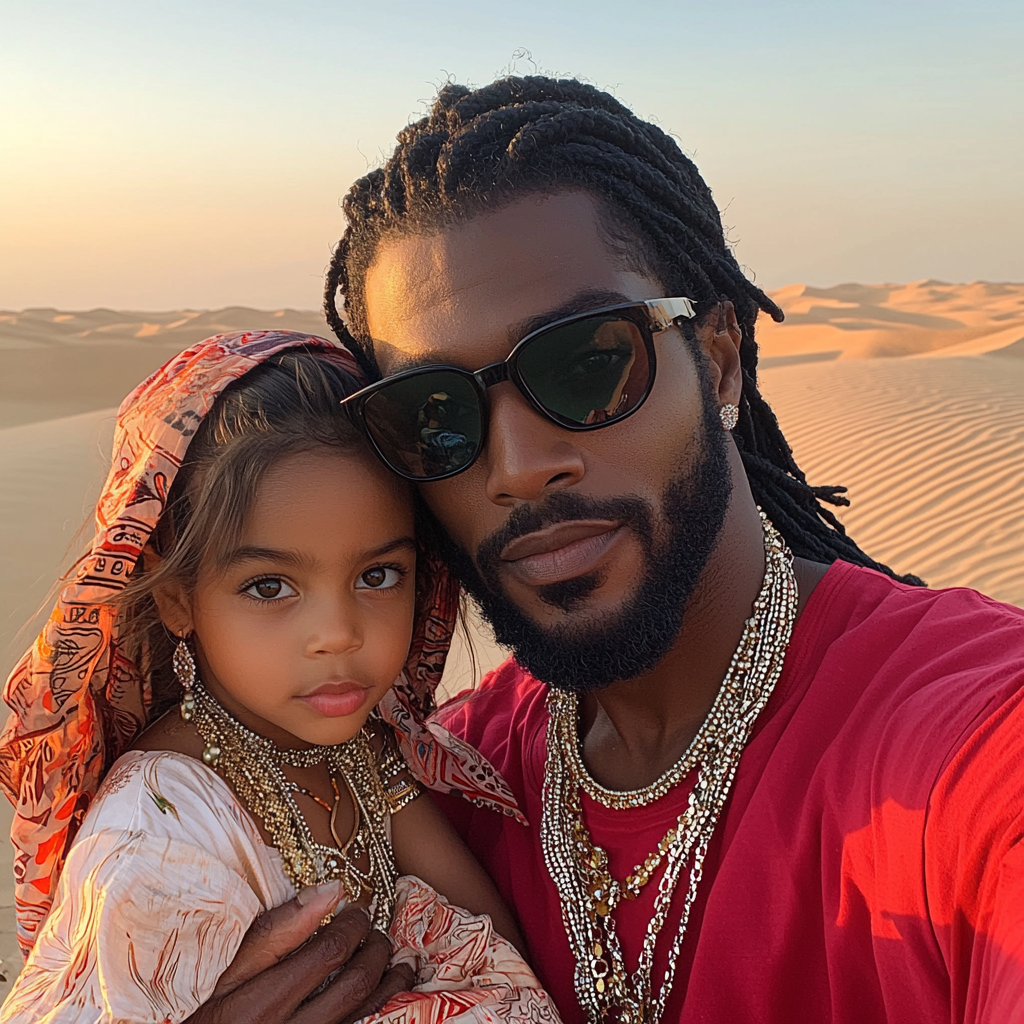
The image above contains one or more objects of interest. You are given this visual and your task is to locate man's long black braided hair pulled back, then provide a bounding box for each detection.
[325,76,922,584]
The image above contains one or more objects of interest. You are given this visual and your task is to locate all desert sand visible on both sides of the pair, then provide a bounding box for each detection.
[0,281,1024,996]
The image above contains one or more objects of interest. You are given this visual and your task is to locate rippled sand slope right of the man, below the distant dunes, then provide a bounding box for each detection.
[762,356,1024,605]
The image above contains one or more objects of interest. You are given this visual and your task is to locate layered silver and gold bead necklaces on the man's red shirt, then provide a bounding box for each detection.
[541,509,798,1024]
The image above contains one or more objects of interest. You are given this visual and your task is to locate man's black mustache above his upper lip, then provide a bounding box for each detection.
[476,490,654,579]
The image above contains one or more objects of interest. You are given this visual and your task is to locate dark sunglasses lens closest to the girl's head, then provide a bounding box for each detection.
[362,371,483,480]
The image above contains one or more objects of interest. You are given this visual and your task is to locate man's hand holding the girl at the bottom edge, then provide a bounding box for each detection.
[185,882,414,1024]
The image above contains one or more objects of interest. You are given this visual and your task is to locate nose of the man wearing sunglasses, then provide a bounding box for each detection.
[481,384,586,505]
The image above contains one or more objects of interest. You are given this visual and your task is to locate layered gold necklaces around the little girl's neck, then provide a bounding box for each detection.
[181,679,398,932]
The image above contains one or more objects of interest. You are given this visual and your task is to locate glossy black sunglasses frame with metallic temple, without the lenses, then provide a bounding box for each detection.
[340,297,696,483]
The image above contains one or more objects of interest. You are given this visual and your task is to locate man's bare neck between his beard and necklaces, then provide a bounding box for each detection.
[581,486,828,790]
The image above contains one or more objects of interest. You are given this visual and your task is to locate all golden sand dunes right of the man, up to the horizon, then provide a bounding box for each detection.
[758,281,1024,604]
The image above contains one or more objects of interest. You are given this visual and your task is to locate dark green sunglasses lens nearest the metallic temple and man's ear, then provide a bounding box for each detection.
[517,315,651,426]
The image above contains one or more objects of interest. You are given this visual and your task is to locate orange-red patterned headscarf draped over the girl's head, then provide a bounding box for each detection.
[0,331,522,953]
